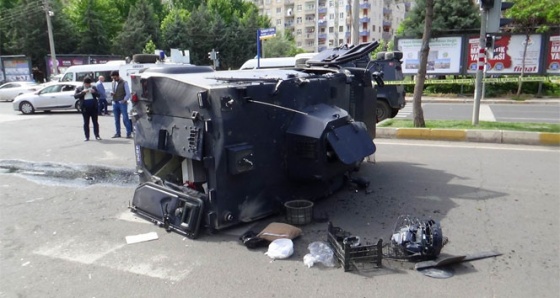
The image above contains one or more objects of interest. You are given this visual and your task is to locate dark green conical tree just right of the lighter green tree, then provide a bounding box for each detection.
[113,0,159,56]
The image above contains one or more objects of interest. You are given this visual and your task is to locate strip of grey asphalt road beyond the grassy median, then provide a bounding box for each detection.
[396,103,560,123]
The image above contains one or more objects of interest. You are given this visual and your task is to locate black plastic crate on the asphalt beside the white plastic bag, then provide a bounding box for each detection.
[327,222,383,272]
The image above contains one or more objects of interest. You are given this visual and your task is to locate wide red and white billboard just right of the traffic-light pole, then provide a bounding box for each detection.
[467,34,542,74]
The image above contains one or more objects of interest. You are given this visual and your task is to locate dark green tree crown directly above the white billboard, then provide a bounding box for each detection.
[397,0,480,38]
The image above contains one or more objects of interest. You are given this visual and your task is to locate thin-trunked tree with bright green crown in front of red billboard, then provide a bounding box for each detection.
[506,0,560,96]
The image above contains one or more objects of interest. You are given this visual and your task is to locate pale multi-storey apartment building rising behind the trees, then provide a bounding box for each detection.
[252,0,411,52]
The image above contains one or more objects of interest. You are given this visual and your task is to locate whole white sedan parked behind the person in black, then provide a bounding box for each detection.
[13,82,82,114]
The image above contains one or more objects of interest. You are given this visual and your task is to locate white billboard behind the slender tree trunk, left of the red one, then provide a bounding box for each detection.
[397,37,462,75]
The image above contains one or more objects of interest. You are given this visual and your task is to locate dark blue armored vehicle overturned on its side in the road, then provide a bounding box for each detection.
[131,42,377,238]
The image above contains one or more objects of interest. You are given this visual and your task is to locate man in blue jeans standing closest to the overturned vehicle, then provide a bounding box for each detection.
[111,70,132,139]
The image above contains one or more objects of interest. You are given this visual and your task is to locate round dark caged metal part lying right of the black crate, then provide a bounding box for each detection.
[388,215,444,260]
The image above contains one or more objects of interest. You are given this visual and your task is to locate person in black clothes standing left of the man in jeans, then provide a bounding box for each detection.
[74,77,101,142]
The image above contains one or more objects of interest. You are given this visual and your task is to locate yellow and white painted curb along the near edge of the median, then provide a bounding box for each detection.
[376,127,560,146]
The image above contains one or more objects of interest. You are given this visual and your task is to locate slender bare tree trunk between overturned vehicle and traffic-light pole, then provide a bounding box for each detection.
[412,0,434,127]
